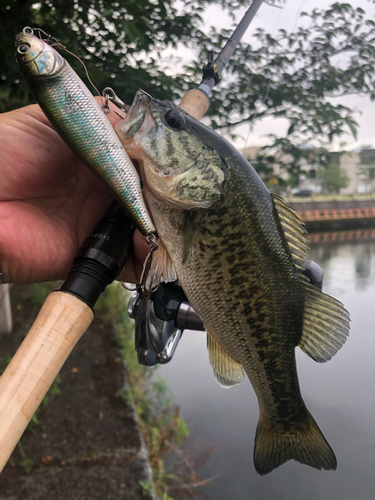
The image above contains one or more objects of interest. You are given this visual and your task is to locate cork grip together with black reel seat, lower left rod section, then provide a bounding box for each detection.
[0,202,135,472]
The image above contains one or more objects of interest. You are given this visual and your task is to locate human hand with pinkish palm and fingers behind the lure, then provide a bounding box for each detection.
[0,104,148,283]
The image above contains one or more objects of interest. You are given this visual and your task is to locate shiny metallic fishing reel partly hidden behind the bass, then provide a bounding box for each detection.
[128,261,323,366]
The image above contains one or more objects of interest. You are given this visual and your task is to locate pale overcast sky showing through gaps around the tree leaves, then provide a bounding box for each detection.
[174,0,375,150]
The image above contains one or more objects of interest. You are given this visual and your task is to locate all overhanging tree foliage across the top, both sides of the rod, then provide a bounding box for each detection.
[0,0,375,175]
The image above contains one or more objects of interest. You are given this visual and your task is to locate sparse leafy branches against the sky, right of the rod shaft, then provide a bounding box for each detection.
[192,2,375,176]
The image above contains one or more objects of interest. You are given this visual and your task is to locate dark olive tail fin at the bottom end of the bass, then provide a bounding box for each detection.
[254,410,337,476]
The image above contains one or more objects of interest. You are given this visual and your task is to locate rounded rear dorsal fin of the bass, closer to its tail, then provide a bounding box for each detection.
[298,283,350,363]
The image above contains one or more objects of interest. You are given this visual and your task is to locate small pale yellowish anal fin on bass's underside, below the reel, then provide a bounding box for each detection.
[207,331,244,389]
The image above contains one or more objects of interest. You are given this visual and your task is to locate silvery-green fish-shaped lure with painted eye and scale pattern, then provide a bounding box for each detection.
[16,32,155,235]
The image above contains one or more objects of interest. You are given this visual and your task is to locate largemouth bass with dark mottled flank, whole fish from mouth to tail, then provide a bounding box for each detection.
[117,91,349,474]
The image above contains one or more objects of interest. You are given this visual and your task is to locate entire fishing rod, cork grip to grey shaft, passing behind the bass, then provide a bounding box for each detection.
[0,0,270,472]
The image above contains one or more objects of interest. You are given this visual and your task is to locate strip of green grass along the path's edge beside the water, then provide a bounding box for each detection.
[95,283,213,500]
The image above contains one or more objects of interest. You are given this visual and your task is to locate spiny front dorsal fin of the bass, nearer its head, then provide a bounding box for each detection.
[271,193,309,274]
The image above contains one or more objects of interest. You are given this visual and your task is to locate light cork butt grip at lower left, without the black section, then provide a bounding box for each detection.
[0,292,94,472]
